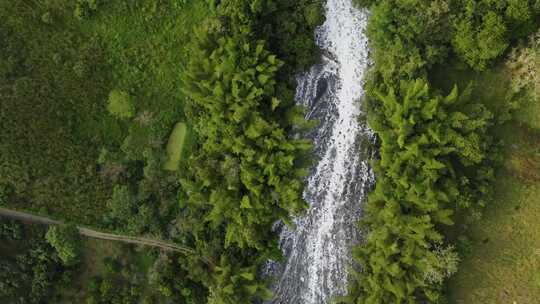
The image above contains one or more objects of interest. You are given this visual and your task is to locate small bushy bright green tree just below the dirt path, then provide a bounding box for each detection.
[45,225,81,266]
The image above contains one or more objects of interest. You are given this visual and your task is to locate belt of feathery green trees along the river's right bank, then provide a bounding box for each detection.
[340,0,540,304]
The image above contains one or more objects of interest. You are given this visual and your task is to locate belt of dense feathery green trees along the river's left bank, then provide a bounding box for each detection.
[169,0,322,304]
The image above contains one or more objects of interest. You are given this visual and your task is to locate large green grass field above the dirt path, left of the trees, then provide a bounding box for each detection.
[0,0,208,226]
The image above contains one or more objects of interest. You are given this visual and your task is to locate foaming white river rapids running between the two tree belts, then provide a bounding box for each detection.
[271,0,373,304]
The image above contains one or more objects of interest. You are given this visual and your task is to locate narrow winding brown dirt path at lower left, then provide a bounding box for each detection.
[0,207,212,265]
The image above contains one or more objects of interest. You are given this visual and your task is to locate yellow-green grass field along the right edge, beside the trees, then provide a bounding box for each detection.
[434,59,540,304]
